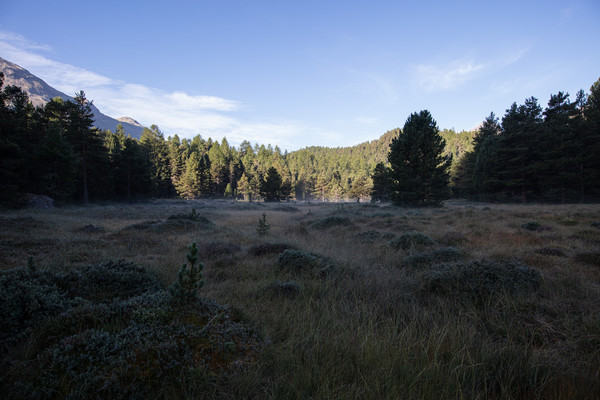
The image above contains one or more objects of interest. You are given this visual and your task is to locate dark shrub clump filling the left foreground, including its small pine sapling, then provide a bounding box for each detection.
[0,250,261,399]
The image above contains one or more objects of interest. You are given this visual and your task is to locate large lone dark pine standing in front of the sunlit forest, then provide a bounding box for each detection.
[388,110,452,207]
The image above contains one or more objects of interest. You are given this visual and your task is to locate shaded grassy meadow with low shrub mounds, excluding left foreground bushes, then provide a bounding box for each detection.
[0,200,600,399]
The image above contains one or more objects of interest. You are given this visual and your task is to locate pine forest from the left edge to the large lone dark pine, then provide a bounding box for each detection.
[0,72,472,205]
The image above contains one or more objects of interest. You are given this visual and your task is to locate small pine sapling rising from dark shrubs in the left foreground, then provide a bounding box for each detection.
[169,242,204,303]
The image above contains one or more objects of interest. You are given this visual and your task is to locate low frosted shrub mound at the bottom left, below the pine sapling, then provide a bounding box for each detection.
[2,291,261,399]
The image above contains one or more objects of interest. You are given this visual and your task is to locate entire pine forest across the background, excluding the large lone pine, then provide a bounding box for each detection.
[0,70,600,206]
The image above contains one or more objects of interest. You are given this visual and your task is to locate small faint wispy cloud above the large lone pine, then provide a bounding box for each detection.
[415,60,484,92]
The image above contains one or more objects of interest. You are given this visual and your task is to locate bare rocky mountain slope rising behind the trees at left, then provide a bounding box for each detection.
[0,57,144,138]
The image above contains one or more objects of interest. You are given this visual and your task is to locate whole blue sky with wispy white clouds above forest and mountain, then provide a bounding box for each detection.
[0,0,600,151]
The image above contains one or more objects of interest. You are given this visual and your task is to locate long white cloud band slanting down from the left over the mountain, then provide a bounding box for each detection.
[0,31,311,148]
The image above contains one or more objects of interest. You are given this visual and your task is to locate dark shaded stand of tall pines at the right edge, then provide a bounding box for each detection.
[452,80,600,203]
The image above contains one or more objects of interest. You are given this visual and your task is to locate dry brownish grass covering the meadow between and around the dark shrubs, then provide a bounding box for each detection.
[0,201,600,399]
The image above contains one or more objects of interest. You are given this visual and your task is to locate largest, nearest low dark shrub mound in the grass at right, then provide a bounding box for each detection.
[422,260,542,299]
